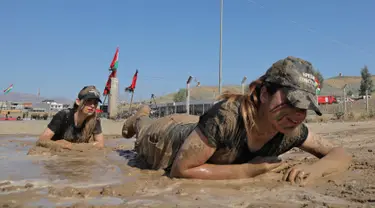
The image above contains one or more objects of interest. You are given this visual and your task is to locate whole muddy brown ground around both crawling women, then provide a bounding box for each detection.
[0,118,375,208]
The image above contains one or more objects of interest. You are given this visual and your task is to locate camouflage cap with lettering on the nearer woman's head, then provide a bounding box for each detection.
[264,56,322,116]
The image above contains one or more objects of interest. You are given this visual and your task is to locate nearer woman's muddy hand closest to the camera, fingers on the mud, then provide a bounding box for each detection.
[283,165,319,186]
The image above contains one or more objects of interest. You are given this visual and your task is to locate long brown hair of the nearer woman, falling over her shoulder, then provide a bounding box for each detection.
[219,76,280,141]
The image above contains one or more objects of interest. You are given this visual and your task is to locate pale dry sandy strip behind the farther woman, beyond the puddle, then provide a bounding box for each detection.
[0,119,124,138]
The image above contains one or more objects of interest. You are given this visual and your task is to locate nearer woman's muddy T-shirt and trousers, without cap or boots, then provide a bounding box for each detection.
[135,101,308,172]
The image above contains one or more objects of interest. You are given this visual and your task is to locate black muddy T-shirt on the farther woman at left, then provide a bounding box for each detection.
[47,109,102,143]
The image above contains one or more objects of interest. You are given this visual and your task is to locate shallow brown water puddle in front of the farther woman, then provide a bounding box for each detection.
[0,138,136,207]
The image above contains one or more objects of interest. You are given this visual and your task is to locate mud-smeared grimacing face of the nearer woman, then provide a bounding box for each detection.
[264,90,306,134]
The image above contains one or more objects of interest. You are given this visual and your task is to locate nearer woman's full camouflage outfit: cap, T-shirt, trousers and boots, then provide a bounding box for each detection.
[123,57,321,171]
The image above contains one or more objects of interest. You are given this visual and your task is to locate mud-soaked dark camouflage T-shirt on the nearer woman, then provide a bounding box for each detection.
[198,101,308,164]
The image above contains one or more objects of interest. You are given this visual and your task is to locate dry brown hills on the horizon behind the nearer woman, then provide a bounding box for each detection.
[151,76,375,103]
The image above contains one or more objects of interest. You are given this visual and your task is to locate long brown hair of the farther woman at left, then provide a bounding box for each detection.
[73,100,97,143]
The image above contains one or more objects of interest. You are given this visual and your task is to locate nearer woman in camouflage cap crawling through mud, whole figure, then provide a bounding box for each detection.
[122,57,351,185]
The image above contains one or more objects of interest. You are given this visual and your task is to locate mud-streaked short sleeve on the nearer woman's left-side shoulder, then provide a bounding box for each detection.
[197,101,238,148]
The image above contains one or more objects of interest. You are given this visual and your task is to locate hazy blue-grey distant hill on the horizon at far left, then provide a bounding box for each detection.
[0,91,73,104]
